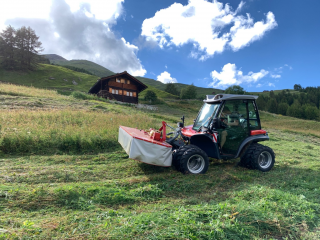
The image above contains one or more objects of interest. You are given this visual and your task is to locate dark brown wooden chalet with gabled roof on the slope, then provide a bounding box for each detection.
[89,71,147,103]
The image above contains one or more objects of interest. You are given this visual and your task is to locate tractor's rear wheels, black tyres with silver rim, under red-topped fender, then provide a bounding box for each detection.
[240,143,275,172]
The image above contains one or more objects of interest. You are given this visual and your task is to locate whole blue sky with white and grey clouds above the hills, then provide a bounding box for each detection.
[0,0,320,92]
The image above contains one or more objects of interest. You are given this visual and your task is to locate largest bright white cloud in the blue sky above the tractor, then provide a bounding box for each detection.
[141,0,277,60]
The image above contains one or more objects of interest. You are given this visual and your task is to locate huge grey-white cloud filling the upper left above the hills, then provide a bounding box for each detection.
[0,0,146,76]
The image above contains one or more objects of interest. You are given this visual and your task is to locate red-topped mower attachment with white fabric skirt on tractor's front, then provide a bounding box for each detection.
[118,126,172,167]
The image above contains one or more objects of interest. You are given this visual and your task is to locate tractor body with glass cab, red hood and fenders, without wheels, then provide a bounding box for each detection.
[181,94,269,159]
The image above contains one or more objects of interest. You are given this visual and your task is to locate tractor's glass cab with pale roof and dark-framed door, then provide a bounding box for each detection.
[192,94,265,158]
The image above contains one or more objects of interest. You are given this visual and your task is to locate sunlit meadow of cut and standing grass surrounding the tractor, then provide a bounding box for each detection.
[0,84,320,239]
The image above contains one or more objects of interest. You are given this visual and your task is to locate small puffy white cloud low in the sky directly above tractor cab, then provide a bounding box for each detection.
[209,63,269,87]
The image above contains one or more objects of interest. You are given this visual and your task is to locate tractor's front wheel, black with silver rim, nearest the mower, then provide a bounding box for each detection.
[179,144,209,174]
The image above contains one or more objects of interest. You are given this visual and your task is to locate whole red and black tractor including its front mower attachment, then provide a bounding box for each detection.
[119,94,275,174]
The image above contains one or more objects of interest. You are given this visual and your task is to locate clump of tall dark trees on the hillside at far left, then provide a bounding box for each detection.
[0,26,43,70]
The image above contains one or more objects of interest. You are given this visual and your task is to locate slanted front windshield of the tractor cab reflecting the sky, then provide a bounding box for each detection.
[193,103,220,131]
